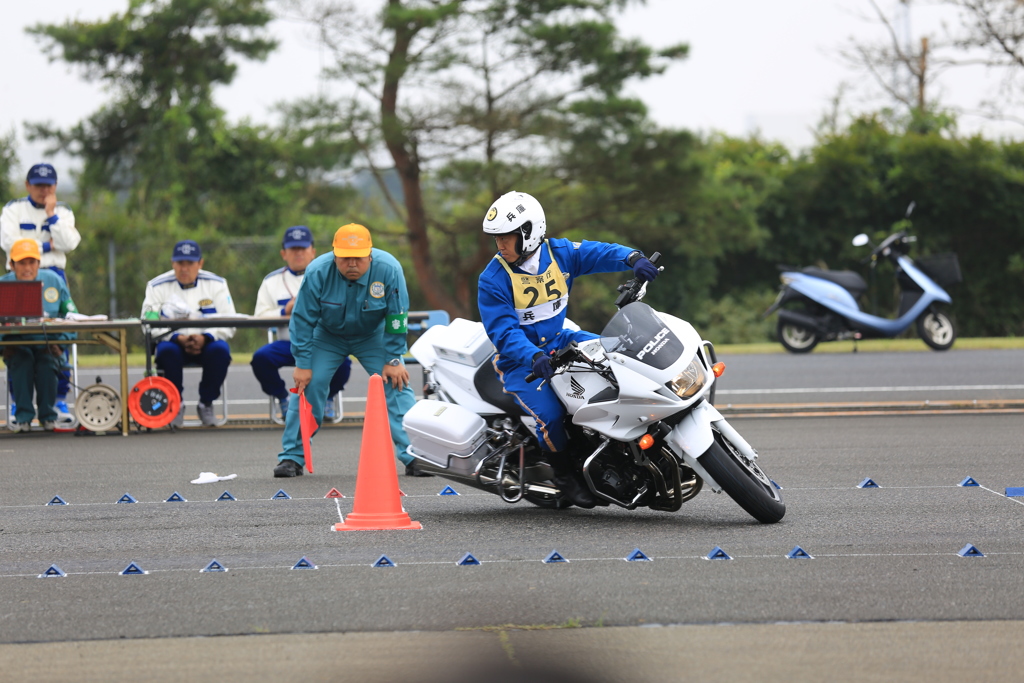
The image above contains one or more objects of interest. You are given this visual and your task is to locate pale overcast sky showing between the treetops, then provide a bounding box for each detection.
[0,0,1024,176]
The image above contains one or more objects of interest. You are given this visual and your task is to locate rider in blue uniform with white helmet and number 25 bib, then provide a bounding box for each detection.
[477,191,657,508]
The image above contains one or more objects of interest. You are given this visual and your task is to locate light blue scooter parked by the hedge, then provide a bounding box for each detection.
[765,230,961,353]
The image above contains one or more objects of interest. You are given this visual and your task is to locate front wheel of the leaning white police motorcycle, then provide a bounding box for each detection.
[697,430,785,524]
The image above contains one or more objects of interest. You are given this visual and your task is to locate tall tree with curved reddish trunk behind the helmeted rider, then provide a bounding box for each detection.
[293,0,686,315]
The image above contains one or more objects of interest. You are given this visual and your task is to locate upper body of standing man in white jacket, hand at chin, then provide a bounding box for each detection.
[0,164,82,283]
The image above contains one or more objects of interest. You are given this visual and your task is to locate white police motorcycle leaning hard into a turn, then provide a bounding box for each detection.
[403,254,785,523]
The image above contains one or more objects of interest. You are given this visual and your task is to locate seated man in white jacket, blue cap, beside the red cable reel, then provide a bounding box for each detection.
[142,240,237,427]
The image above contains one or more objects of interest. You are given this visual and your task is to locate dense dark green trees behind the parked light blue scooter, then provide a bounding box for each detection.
[753,117,1024,336]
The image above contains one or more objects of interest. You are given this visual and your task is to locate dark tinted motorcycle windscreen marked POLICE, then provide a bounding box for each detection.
[601,301,683,370]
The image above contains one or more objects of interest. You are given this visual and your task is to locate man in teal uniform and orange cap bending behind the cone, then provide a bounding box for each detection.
[273,223,416,477]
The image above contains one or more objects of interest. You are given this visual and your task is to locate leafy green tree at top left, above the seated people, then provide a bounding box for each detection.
[29,0,309,230]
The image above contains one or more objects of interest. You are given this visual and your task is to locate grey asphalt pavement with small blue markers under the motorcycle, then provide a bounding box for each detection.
[0,351,1024,681]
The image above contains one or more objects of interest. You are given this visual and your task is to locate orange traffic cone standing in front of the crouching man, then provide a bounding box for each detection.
[334,375,423,531]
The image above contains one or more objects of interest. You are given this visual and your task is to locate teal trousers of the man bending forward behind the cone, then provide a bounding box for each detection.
[278,337,416,465]
